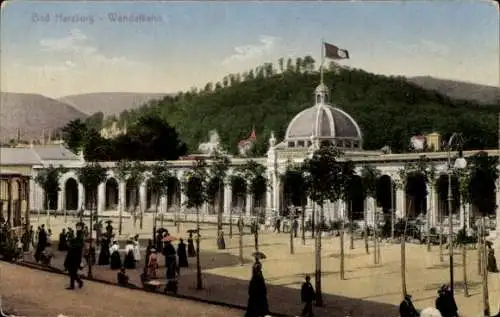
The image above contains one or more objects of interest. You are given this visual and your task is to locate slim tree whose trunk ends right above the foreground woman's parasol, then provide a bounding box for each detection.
[241,160,267,252]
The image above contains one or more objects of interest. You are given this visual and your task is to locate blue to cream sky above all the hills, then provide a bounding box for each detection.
[0,0,499,97]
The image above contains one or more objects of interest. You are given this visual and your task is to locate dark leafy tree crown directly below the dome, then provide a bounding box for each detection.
[306,146,344,206]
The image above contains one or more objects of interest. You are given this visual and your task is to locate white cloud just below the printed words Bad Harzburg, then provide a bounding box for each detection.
[39,29,141,70]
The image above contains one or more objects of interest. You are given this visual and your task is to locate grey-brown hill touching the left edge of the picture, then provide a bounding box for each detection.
[0,92,87,141]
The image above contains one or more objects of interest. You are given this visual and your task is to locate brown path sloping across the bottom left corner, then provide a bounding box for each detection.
[0,262,243,317]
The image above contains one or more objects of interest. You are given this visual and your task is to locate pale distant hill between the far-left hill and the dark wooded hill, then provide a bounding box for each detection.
[59,92,168,117]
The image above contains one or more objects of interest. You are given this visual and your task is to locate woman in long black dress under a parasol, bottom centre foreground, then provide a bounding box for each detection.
[245,262,269,317]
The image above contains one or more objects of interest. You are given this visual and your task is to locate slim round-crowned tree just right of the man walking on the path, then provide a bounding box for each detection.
[77,162,107,277]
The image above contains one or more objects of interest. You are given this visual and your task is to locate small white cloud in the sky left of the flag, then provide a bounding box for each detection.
[222,35,279,65]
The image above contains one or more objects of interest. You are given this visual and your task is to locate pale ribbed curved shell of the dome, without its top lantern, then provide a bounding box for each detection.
[285,103,362,140]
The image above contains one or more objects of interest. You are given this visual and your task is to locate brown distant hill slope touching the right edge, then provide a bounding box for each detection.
[408,76,500,105]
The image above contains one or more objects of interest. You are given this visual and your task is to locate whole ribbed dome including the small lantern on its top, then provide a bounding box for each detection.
[285,84,362,149]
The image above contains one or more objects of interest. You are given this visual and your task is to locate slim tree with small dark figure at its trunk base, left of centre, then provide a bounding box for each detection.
[207,151,231,249]
